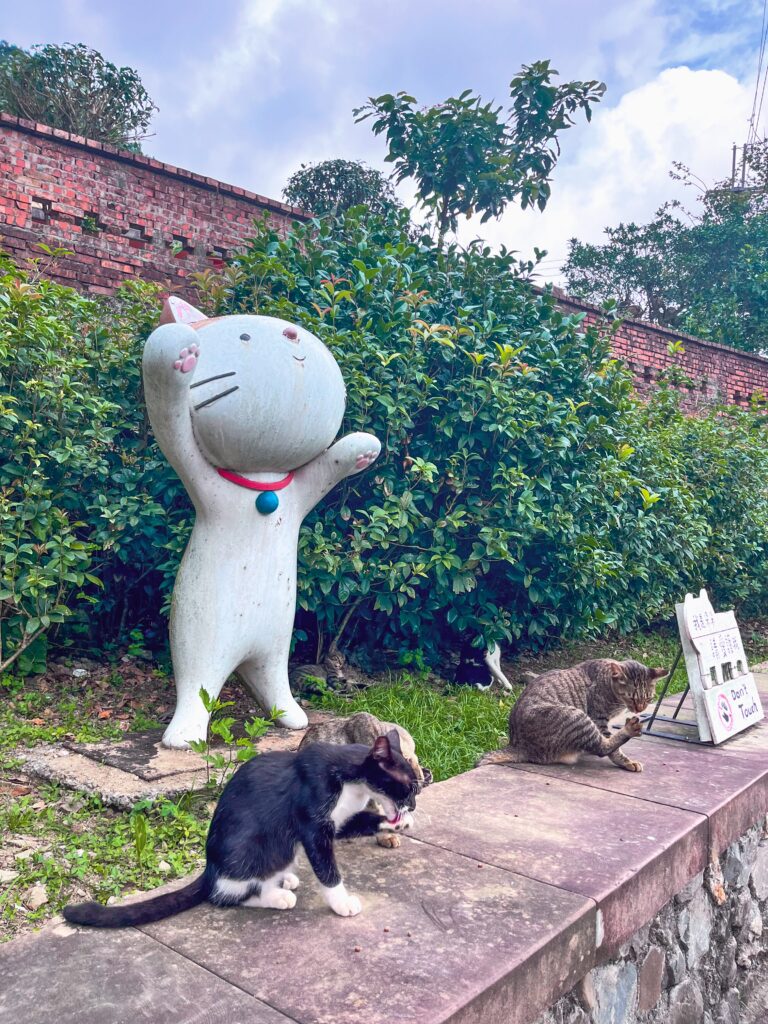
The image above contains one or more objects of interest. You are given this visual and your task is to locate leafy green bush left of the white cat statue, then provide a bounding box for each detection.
[0,254,181,671]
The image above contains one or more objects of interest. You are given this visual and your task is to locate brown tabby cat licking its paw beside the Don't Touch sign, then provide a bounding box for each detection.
[481,658,667,771]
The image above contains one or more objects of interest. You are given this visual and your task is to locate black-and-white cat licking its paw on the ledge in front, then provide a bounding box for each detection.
[63,730,419,928]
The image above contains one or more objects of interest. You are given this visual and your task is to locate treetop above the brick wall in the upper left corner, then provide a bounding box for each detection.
[0,43,157,148]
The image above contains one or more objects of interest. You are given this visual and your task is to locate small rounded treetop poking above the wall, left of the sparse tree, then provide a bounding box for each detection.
[283,160,397,217]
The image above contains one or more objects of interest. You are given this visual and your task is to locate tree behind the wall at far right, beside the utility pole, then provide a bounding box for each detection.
[562,140,768,351]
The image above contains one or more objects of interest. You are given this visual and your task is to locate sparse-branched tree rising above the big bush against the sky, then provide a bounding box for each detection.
[354,60,605,245]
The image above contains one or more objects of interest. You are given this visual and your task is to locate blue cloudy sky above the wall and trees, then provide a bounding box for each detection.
[6,0,768,283]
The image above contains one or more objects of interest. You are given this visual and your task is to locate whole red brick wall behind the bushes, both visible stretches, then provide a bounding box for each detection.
[0,114,768,411]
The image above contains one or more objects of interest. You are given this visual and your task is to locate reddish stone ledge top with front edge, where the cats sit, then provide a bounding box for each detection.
[0,680,768,1024]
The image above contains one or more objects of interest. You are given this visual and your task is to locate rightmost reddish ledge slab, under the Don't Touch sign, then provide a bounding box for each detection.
[509,728,768,854]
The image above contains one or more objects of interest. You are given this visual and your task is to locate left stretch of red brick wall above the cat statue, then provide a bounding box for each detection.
[0,114,306,294]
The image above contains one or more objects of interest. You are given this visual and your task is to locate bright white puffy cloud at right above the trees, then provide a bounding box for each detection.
[473,68,752,280]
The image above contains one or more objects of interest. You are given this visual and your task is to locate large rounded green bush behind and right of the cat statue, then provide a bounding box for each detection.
[193,210,733,660]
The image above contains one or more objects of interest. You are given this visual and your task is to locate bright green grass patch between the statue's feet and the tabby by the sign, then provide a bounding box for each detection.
[313,672,514,782]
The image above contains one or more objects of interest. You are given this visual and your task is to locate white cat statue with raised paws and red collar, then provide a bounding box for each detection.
[143,297,381,746]
